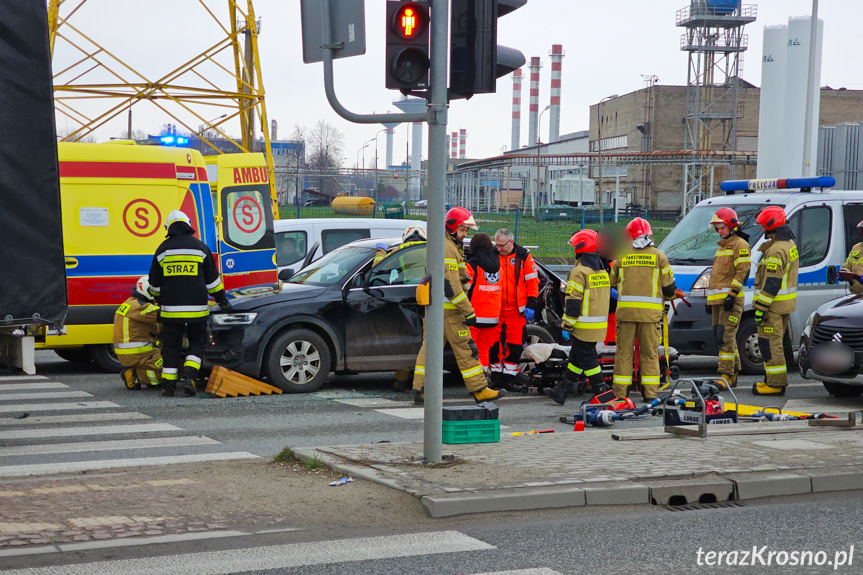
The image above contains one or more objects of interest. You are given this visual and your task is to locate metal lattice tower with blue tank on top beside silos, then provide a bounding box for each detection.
[677,0,756,213]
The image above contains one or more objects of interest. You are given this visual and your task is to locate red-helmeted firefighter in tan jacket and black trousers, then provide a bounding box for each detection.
[547,230,611,405]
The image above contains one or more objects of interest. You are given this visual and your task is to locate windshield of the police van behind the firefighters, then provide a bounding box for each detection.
[659,204,773,265]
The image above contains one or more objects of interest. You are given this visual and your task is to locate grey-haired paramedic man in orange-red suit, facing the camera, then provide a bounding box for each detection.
[489,228,539,391]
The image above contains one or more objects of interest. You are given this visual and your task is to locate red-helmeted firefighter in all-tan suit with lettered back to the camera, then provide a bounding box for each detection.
[611,218,677,401]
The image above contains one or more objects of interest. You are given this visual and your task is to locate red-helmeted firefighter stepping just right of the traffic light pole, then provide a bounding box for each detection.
[413,207,505,405]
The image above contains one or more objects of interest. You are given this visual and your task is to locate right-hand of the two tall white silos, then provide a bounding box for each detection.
[780,16,824,178]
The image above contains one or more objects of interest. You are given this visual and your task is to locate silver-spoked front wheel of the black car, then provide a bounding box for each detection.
[264,329,330,393]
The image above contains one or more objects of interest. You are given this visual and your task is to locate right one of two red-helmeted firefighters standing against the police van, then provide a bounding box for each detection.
[752,206,800,396]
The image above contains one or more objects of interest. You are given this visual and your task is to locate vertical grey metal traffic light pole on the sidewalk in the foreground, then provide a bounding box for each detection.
[423,0,449,463]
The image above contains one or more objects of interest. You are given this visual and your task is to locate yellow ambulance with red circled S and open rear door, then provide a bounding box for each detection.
[44,142,278,371]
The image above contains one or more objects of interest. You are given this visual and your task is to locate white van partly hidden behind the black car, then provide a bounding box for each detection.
[273,218,426,281]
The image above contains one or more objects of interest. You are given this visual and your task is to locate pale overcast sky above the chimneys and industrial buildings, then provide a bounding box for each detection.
[55,0,863,167]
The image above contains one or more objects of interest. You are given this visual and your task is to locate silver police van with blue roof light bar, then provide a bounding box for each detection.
[659,177,863,374]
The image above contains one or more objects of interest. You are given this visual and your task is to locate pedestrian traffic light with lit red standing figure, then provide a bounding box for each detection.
[386,0,430,93]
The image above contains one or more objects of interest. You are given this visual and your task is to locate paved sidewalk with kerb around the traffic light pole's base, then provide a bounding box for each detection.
[297,421,863,517]
